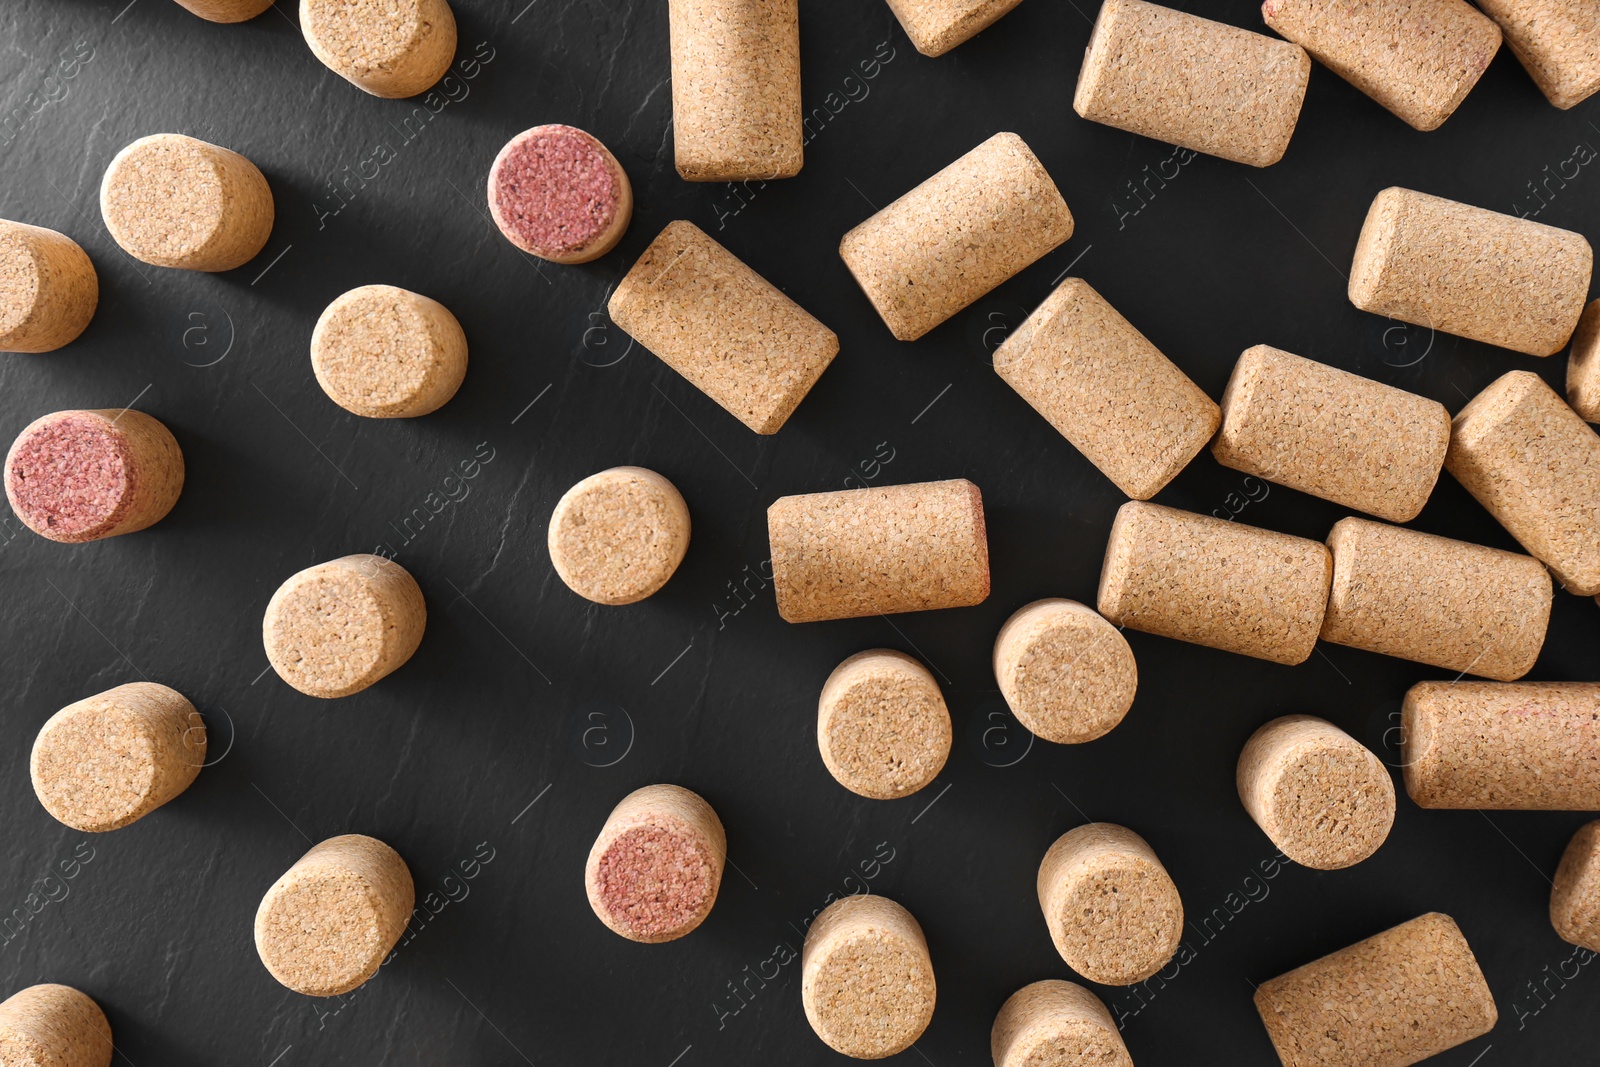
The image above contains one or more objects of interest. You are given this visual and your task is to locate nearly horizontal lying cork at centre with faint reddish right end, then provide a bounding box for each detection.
[766,478,989,622]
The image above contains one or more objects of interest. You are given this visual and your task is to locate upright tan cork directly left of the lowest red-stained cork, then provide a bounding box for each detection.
[256,833,416,997]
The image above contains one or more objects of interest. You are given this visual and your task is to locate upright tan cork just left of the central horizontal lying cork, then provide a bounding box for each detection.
[549,467,690,605]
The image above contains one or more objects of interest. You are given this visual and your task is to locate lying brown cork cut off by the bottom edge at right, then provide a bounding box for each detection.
[1256,912,1499,1067]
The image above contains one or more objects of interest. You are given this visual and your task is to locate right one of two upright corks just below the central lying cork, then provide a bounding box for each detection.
[994,600,1139,744]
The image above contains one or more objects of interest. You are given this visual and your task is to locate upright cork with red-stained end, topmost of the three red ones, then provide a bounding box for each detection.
[490,125,634,262]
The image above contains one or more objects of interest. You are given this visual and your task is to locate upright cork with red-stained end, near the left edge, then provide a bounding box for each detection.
[5,408,184,544]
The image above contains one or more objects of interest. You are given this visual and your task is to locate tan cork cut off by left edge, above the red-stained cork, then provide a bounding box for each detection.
[0,219,99,352]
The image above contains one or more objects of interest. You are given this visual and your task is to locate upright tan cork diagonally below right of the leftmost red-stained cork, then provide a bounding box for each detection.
[261,553,427,697]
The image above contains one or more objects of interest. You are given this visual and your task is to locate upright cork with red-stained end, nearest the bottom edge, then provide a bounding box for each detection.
[584,785,728,944]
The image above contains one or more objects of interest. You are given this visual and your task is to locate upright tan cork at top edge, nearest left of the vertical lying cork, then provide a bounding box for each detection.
[299,0,456,99]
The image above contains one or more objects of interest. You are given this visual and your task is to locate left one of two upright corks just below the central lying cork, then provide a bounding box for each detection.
[816,648,952,800]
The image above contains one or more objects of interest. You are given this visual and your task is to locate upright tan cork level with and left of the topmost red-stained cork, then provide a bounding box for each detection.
[101,133,274,272]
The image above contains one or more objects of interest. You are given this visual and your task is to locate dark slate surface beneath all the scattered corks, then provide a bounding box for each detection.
[0,0,1600,1067]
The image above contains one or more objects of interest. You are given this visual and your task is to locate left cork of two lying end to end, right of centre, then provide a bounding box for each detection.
[1098,501,1333,664]
